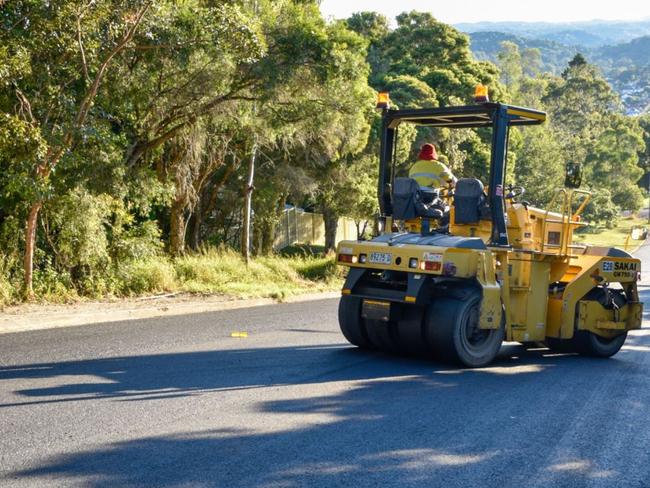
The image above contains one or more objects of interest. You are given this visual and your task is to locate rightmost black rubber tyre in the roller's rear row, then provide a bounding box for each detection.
[425,294,504,368]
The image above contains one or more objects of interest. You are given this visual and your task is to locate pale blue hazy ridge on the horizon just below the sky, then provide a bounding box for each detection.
[455,19,650,48]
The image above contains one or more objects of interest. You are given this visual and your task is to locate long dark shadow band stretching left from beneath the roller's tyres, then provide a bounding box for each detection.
[0,345,552,408]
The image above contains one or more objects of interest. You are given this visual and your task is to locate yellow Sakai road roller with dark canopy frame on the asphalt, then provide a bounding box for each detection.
[336,89,643,367]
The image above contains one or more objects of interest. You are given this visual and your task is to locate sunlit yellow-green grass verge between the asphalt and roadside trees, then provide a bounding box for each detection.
[0,247,344,308]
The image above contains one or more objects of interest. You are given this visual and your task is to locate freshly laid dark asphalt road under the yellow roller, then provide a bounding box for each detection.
[0,248,650,488]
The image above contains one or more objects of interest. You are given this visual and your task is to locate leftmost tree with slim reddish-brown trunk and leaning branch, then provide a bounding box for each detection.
[0,1,151,296]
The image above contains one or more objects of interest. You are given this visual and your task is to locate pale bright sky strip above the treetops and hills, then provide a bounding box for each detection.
[321,0,650,24]
